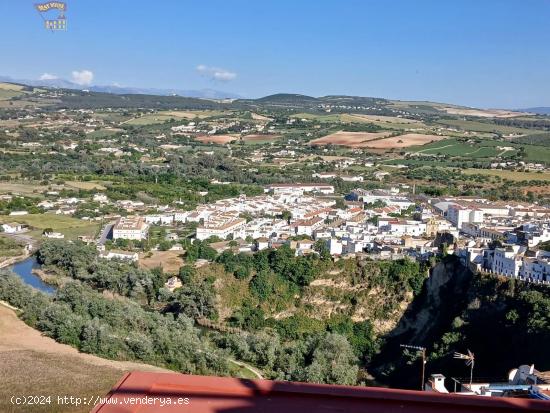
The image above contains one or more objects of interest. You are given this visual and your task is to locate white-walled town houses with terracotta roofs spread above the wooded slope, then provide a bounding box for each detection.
[10,183,550,282]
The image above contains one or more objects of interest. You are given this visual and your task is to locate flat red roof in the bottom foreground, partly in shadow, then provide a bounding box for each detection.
[92,372,550,413]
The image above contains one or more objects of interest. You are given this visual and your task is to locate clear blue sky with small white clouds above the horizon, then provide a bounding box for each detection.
[0,0,550,108]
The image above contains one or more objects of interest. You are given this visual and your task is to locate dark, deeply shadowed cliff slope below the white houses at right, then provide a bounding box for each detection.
[369,256,550,388]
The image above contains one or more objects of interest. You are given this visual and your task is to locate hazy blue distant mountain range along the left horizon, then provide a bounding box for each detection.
[0,76,241,99]
